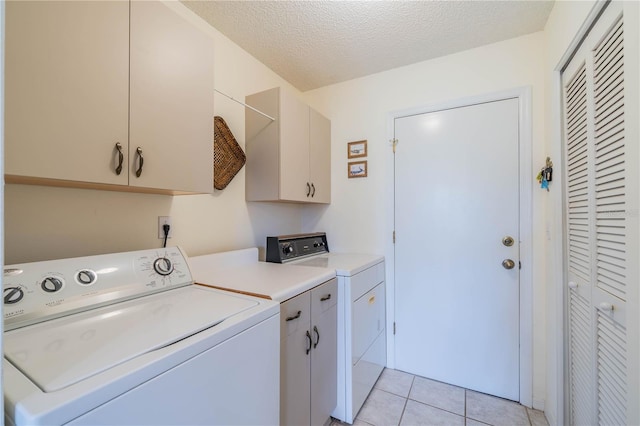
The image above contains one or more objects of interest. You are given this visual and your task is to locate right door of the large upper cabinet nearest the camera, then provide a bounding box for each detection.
[129,1,213,192]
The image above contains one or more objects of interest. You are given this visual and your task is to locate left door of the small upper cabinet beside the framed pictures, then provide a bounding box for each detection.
[280,89,311,201]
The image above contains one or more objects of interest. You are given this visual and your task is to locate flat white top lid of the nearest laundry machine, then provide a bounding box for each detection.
[4,285,258,392]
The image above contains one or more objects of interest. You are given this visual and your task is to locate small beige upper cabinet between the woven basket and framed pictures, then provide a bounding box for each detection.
[245,88,331,203]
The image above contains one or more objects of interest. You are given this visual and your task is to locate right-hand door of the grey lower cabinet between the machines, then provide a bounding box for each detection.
[311,279,338,426]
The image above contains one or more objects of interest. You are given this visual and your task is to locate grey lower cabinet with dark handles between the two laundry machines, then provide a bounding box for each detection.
[280,278,338,426]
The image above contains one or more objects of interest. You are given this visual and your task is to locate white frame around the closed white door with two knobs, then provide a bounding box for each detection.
[385,86,533,407]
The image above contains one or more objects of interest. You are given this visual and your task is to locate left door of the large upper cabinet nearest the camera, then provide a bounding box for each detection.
[5,1,129,185]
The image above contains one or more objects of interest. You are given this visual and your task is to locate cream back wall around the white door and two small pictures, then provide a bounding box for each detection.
[303,32,549,408]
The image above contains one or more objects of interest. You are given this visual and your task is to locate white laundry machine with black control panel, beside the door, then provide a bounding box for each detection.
[266,233,387,423]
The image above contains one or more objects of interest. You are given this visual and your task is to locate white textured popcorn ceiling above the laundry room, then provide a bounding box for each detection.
[183,0,553,91]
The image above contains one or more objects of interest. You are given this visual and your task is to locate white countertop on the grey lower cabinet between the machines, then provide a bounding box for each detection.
[190,252,336,302]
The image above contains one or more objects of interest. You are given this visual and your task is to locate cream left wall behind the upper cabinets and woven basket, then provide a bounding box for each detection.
[5,2,301,264]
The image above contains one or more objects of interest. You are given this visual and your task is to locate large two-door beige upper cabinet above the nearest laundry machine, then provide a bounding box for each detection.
[5,1,213,193]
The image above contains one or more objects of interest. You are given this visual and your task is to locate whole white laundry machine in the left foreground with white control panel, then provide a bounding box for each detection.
[3,248,279,425]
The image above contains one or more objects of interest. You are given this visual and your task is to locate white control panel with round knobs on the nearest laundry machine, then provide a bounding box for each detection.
[2,247,193,330]
